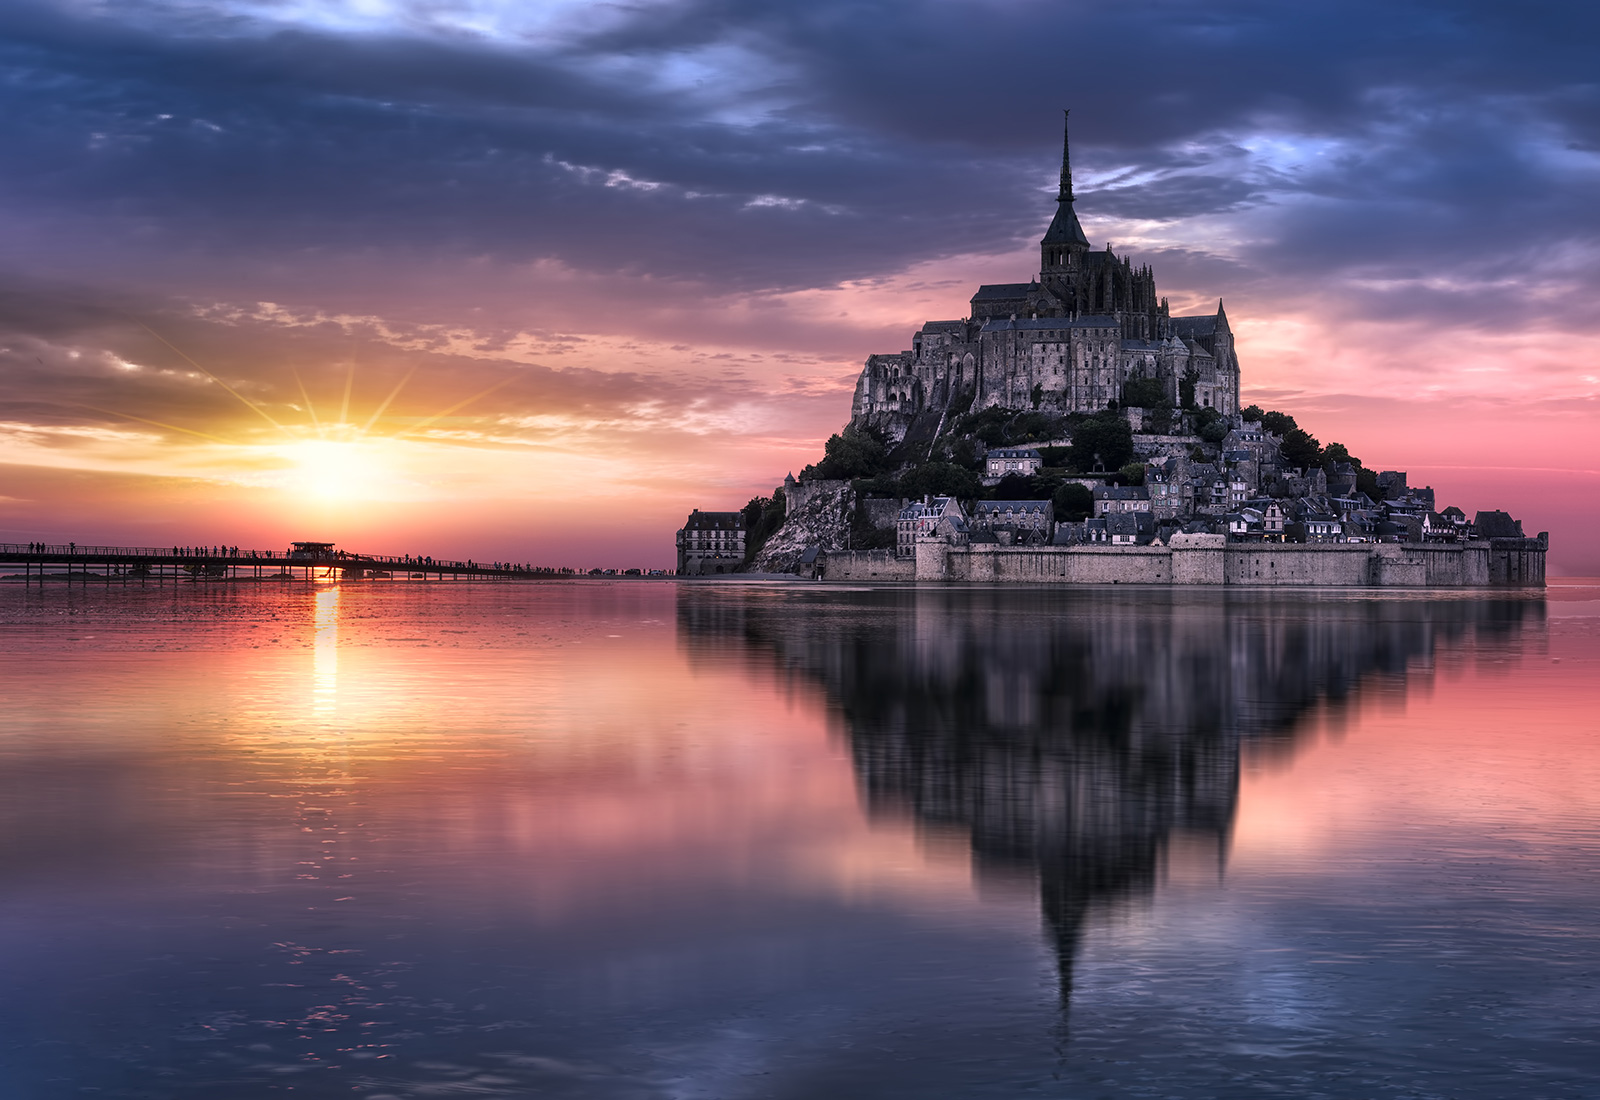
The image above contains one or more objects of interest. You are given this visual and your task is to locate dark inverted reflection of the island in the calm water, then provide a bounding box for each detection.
[678,588,1544,1009]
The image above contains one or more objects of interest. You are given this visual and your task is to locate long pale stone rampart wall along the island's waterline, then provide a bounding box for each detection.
[818,534,1549,588]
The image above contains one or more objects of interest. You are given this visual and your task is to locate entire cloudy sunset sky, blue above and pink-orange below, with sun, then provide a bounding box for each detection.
[0,0,1600,565]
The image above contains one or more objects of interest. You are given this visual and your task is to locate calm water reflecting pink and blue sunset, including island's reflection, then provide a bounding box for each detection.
[0,582,1600,1100]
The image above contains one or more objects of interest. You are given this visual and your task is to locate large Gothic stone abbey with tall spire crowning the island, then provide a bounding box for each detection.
[851,115,1238,440]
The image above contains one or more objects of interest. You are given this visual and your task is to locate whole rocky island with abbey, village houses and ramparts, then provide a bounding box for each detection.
[677,115,1549,587]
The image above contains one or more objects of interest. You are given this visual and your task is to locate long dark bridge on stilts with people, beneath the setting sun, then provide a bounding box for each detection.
[0,542,544,585]
